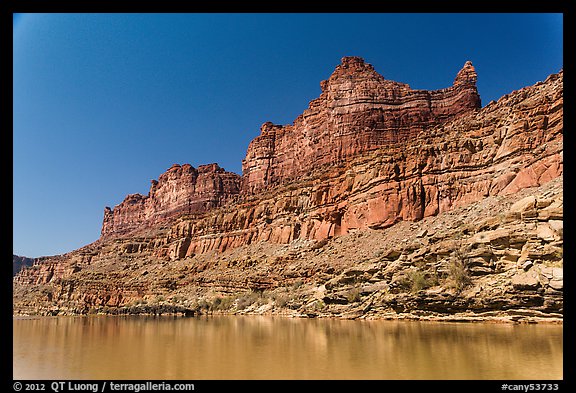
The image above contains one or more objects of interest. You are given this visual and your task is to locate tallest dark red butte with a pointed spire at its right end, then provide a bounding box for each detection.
[242,57,480,193]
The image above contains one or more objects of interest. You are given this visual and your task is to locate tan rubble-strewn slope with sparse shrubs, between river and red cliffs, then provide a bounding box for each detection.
[13,178,563,323]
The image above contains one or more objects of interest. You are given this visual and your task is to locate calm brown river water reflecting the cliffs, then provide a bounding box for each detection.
[13,316,562,380]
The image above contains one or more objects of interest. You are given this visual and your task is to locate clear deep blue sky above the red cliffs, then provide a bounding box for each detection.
[13,13,563,257]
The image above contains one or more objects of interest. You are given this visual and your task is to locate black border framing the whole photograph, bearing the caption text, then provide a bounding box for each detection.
[5,0,576,392]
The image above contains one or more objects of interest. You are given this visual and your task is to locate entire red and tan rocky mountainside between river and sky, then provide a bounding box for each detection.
[14,58,563,318]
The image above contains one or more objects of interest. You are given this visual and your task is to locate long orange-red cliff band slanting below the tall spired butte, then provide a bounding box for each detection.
[150,68,563,259]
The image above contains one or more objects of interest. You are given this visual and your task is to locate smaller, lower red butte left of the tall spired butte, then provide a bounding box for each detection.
[101,164,241,237]
